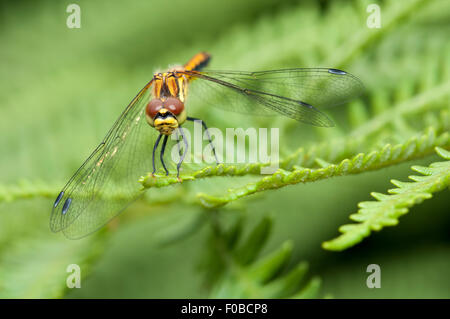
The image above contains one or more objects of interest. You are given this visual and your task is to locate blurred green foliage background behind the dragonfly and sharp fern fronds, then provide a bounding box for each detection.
[0,0,450,298]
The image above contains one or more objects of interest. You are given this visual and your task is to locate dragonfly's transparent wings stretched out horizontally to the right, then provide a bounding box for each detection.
[184,68,364,126]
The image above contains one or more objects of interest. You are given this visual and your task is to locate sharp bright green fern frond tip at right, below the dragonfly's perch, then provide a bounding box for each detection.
[322,147,450,251]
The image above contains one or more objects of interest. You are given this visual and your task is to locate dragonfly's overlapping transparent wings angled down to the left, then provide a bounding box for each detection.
[50,82,159,238]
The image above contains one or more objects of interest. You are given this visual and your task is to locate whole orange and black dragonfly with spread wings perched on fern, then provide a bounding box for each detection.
[50,52,363,239]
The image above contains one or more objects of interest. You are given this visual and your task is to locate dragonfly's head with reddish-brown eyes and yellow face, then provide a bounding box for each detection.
[145,97,186,135]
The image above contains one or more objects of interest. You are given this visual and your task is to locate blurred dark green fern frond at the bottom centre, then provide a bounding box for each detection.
[208,217,321,299]
